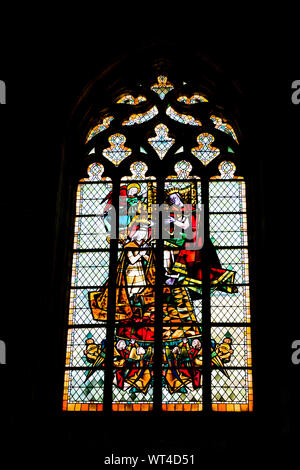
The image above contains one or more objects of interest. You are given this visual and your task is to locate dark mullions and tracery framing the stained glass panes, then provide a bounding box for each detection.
[59,69,253,415]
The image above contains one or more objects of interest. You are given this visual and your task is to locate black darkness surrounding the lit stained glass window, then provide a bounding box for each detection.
[0,4,300,467]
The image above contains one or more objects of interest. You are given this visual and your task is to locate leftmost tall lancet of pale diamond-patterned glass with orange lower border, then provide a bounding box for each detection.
[63,169,112,411]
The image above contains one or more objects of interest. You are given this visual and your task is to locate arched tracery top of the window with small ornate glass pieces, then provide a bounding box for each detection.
[81,75,239,173]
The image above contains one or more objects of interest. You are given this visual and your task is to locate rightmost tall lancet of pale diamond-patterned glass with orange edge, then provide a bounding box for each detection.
[209,161,253,411]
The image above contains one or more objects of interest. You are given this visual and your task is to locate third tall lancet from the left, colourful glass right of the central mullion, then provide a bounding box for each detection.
[162,176,203,412]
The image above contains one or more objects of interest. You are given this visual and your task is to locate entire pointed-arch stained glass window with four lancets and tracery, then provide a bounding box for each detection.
[63,75,253,413]
